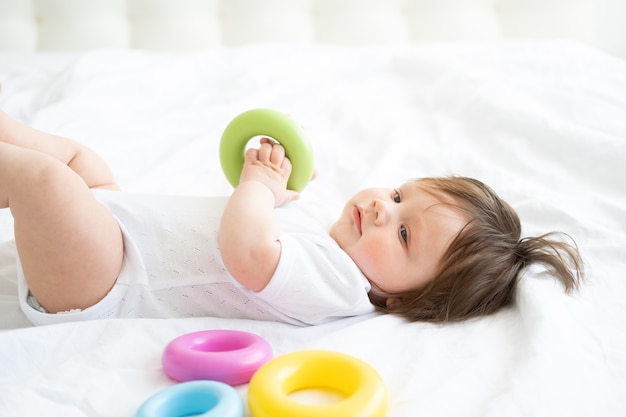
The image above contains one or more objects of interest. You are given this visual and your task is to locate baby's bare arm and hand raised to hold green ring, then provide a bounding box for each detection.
[219,139,298,291]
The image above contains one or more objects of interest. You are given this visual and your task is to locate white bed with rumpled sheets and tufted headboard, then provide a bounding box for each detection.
[0,1,626,417]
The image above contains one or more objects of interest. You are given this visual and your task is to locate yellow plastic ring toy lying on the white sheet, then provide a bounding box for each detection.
[248,350,388,417]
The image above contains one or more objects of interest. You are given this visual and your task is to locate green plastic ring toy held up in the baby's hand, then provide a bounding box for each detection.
[220,109,314,191]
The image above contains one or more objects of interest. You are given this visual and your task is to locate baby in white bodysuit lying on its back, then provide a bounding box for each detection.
[0,112,582,325]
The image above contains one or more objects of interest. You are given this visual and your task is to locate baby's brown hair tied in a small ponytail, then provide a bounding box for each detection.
[370,177,583,323]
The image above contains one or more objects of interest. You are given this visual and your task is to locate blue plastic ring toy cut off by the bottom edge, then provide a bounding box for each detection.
[135,381,244,417]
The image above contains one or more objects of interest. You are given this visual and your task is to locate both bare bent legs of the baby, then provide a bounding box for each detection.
[0,115,123,312]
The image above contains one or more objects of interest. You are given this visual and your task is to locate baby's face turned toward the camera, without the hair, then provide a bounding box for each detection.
[330,181,467,302]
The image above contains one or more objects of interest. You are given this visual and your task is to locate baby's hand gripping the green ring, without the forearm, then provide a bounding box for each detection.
[239,138,299,207]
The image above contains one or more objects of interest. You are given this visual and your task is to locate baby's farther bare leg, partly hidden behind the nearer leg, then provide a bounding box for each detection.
[0,111,118,190]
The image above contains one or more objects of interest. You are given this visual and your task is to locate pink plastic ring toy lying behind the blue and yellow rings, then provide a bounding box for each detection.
[161,330,272,385]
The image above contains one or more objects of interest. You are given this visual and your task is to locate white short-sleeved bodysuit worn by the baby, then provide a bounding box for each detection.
[18,190,374,325]
